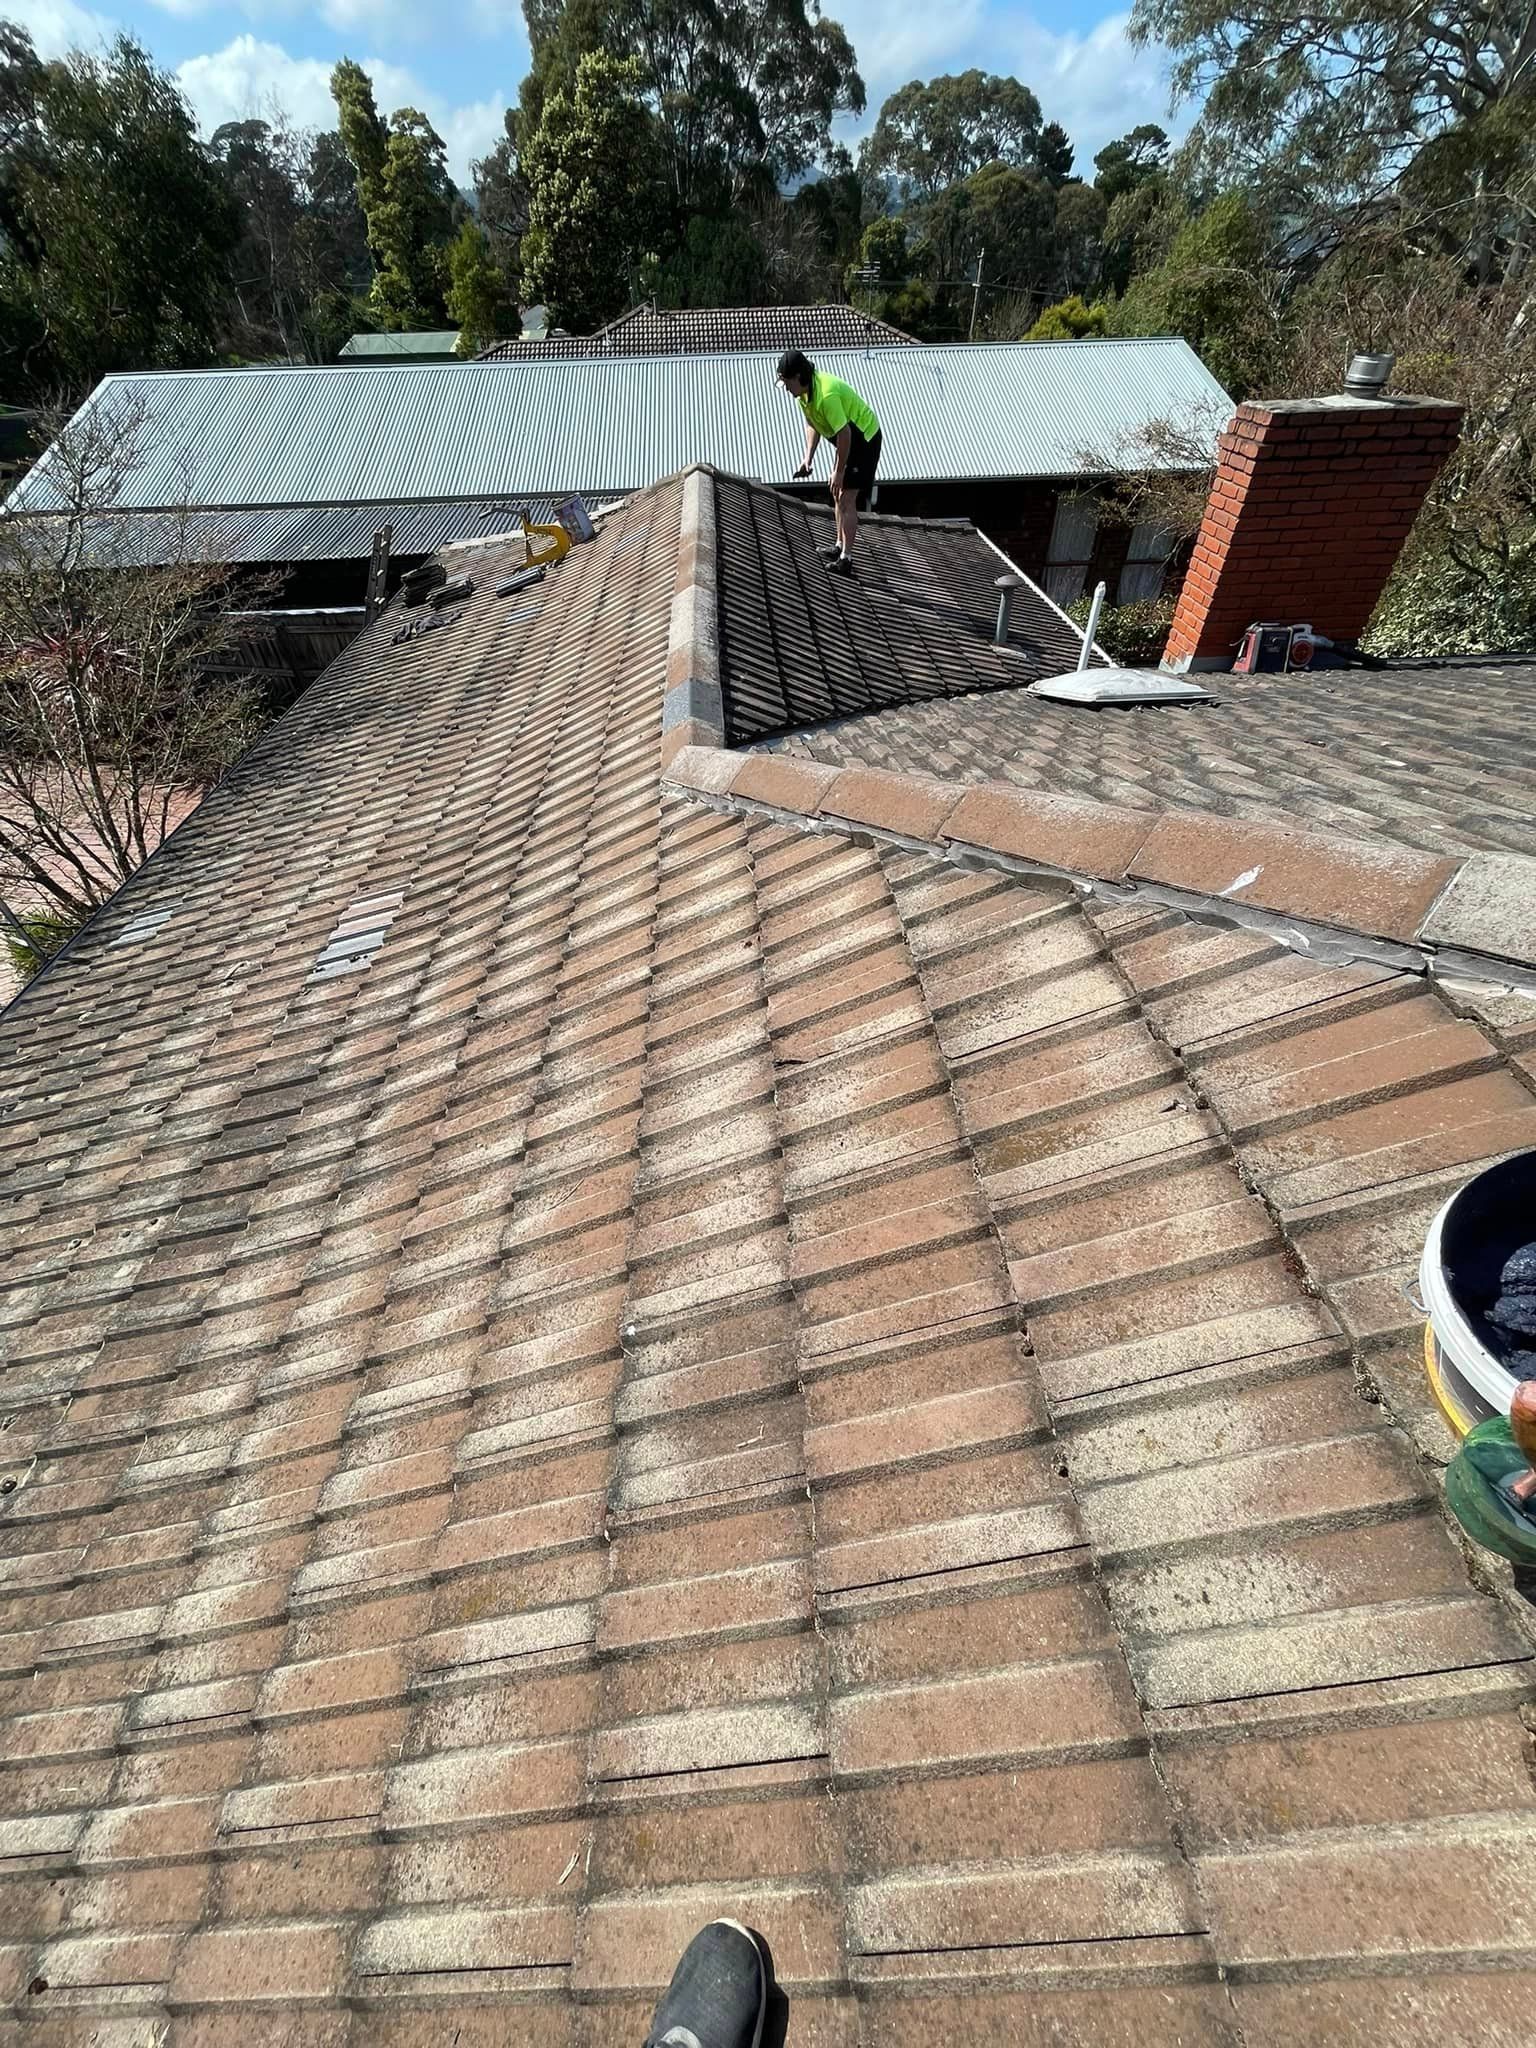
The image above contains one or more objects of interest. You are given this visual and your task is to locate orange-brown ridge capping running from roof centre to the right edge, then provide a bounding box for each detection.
[664,749,1536,995]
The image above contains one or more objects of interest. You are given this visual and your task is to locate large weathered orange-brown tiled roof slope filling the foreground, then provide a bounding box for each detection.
[0,471,1536,2048]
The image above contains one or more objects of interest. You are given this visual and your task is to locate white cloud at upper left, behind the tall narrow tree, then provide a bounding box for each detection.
[176,35,508,184]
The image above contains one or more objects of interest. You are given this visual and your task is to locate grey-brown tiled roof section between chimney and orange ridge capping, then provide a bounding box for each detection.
[770,662,1536,854]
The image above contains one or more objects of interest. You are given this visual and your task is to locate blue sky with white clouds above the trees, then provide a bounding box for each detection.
[0,0,1176,184]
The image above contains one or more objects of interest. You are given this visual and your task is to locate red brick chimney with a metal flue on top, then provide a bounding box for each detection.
[1163,397,1462,670]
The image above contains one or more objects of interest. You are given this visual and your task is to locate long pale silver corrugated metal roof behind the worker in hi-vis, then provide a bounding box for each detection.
[12,340,1231,510]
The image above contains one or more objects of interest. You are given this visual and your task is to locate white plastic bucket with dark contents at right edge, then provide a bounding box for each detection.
[1417,1153,1536,1436]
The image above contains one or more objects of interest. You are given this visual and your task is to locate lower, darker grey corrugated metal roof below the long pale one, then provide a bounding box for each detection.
[70,498,553,567]
